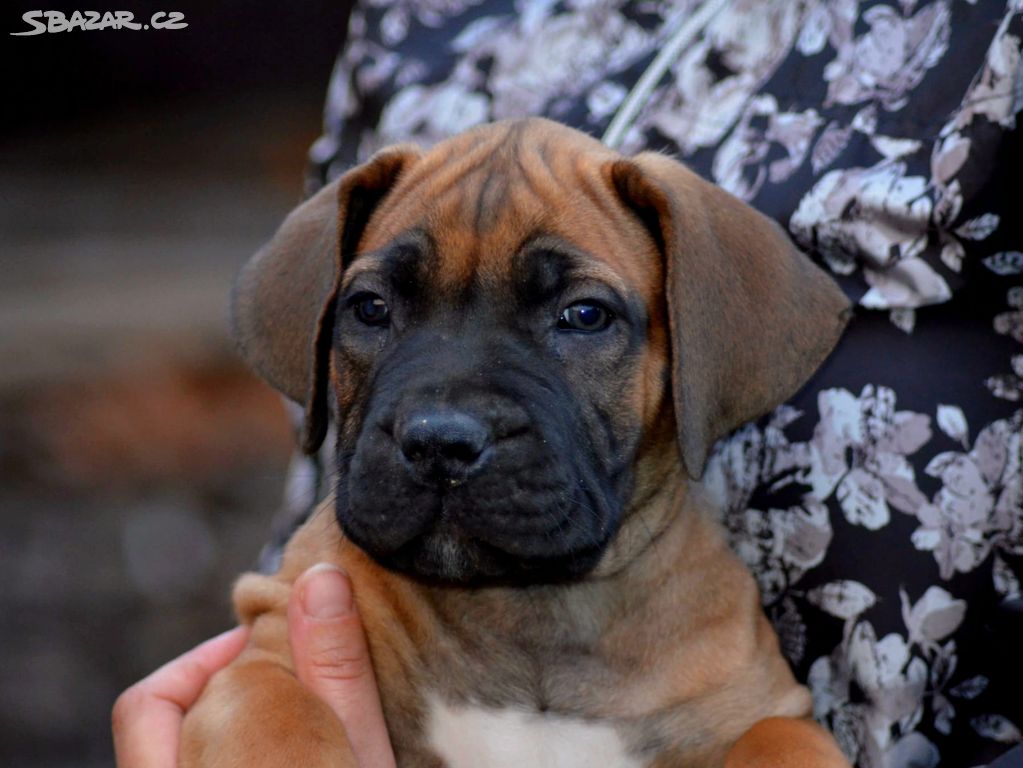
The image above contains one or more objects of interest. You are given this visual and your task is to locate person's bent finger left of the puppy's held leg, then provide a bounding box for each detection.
[113,627,249,768]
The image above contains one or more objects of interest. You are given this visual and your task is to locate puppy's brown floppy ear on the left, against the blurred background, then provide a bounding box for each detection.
[231,145,419,453]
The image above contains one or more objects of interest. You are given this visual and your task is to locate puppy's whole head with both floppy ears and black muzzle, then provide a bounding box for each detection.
[234,120,847,582]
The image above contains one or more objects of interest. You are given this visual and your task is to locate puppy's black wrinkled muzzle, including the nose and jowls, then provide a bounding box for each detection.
[338,329,621,582]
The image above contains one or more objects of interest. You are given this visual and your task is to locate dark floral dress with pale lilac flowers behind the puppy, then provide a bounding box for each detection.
[272,0,1023,768]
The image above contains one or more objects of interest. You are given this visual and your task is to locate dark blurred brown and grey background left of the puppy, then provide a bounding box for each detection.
[0,0,349,768]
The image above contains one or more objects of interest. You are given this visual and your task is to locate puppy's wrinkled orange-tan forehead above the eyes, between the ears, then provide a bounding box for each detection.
[348,126,663,303]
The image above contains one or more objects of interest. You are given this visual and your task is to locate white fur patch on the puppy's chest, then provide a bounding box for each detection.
[427,697,641,768]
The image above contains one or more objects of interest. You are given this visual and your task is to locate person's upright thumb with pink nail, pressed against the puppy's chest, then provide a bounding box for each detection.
[287,562,395,768]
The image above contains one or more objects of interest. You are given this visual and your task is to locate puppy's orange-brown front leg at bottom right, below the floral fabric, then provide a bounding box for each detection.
[724,717,849,768]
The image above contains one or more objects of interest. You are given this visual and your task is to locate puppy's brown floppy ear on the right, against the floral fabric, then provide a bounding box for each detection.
[611,152,850,479]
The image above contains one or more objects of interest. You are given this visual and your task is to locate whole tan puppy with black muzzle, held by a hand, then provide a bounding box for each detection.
[182,120,847,768]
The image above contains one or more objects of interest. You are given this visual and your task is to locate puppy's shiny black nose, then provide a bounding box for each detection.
[395,409,490,483]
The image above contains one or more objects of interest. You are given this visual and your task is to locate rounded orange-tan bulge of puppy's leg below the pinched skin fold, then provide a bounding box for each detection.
[179,661,356,768]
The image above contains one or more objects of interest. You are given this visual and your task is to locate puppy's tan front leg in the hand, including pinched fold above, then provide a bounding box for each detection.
[179,575,356,768]
